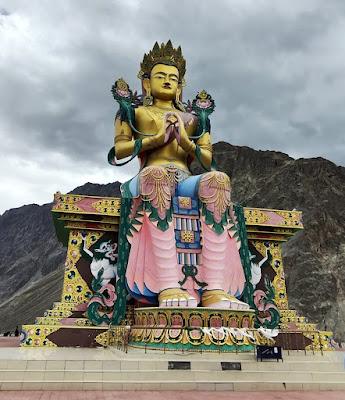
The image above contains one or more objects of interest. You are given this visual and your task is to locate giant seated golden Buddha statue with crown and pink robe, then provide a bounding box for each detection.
[112,41,249,309]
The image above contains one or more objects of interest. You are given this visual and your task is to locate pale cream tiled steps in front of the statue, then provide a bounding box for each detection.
[0,348,345,392]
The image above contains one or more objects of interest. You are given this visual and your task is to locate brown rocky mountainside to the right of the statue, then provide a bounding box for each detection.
[207,142,345,341]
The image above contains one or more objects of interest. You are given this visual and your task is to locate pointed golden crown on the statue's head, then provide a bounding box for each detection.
[138,40,186,81]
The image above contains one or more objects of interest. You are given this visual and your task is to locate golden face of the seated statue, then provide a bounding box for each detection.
[150,64,179,100]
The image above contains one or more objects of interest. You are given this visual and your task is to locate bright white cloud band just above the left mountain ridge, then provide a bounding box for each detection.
[0,153,136,214]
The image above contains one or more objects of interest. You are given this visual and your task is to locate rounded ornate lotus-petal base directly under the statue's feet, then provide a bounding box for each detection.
[129,307,258,352]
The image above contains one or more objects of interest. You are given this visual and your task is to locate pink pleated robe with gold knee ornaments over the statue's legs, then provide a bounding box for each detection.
[126,167,245,302]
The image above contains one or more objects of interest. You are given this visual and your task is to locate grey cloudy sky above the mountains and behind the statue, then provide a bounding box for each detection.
[0,0,345,214]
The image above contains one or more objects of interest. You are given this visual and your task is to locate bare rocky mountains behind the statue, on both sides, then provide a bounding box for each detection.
[0,142,345,341]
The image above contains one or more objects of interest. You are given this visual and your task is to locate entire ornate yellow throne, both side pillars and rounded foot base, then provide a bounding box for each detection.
[22,193,331,351]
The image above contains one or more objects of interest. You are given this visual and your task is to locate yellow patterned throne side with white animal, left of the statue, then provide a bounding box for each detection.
[22,193,120,347]
